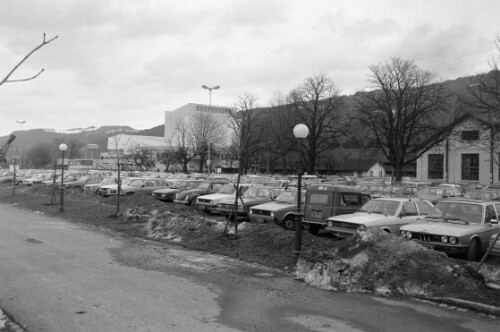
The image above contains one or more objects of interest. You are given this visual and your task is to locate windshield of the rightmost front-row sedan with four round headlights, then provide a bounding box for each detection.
[426,202,483,224]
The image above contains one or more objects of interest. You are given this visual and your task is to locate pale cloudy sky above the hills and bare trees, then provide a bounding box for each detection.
[0,0,500,136]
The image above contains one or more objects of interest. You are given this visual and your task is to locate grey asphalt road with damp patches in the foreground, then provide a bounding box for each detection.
[0,204,500,332]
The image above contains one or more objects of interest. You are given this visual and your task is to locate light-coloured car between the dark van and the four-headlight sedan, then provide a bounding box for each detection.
[325,197,432,238]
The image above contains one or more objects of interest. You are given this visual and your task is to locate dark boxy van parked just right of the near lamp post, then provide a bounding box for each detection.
[302,184,371,235]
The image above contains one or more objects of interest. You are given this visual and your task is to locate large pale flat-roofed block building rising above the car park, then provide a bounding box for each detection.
[165,103,231,142]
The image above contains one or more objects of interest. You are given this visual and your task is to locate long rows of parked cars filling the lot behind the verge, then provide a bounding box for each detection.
[0,169,500,260]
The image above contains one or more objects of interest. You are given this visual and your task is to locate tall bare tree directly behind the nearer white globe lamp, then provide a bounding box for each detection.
[290,73,343,173]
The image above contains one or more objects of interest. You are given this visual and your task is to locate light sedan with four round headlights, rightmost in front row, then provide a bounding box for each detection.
[400,199,500,260]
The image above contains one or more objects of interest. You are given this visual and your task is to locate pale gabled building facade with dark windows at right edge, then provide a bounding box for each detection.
[417,116,500,185]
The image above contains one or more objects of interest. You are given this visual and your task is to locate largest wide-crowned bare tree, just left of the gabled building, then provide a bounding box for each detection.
[355,58,449,181]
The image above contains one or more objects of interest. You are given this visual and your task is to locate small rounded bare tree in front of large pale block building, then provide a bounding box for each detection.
[188,112,227,172]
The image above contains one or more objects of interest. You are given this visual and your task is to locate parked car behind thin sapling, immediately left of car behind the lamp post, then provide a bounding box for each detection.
[217,186,284,217]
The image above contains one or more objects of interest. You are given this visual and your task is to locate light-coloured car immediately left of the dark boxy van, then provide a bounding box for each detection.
[250,189,306,230]
